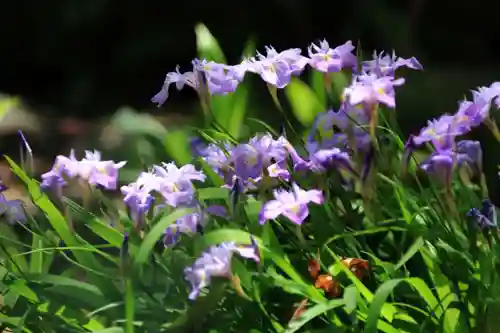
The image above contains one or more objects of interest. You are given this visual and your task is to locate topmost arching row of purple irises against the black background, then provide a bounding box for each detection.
[151,40,422,107]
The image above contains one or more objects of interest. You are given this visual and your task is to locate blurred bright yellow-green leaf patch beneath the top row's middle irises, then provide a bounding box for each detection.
[285,78,323,126]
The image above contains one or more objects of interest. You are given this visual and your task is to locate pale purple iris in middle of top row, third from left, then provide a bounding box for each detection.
[245,47,309,89]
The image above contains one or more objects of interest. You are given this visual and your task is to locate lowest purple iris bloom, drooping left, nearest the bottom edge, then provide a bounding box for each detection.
[184,238,260,300]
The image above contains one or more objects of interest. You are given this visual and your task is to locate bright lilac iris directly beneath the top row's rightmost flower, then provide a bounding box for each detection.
[344,74,405,108]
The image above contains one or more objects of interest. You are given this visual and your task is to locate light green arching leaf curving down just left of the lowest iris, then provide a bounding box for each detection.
[134,208,194,267]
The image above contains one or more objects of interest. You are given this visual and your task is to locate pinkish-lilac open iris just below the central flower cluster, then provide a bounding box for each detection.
[259,183,323,225]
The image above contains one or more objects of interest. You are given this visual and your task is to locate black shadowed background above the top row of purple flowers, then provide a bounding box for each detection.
[0,0,500,119]
